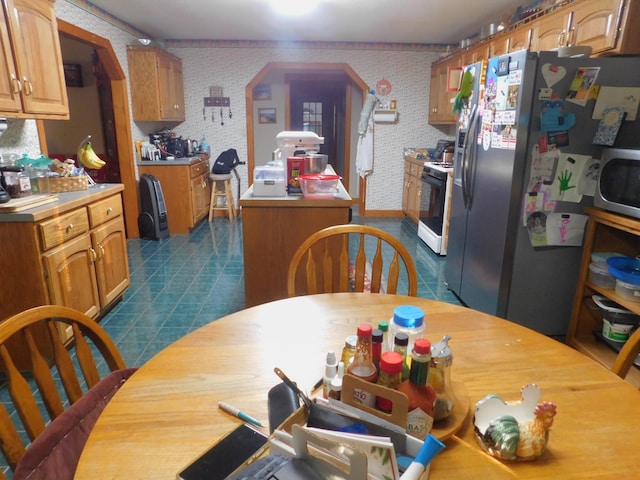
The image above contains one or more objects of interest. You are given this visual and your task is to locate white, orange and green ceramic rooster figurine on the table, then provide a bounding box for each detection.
[474,384,556,460]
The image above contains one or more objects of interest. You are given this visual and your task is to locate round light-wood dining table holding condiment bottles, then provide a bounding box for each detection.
[75,293,640,480]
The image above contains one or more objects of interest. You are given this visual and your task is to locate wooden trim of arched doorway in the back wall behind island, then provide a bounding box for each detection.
[245,62,369,216]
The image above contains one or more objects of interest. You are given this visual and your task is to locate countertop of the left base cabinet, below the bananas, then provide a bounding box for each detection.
[0,183,124,222]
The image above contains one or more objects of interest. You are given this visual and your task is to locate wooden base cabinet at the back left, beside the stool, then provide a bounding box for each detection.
[138,157,211,234]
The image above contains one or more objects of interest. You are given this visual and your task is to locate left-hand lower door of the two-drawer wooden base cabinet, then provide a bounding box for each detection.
[43,233,100,318]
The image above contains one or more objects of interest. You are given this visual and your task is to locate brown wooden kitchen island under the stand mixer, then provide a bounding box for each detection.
[240,178,353,307]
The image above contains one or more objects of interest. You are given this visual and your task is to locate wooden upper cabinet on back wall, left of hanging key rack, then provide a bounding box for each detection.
[127,46,185,122]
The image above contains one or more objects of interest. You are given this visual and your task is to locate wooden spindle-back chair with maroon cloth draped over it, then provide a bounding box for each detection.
[0,305,135,479]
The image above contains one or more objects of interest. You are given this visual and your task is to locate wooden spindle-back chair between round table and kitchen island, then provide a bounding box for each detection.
[287,224,418,297]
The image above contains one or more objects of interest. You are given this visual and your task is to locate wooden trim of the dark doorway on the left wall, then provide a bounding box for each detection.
[36,19,139,238]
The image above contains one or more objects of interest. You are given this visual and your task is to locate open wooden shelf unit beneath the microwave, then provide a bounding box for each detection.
[567,208,640,387]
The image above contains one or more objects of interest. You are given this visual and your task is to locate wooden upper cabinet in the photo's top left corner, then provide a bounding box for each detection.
[0,0,69,119]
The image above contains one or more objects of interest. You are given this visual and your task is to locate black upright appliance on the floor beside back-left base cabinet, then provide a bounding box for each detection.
[138,173,169,240]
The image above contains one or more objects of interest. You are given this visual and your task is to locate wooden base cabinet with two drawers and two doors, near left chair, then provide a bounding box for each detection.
[0,184,130,368]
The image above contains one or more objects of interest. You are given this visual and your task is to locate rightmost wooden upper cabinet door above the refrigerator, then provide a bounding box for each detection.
[569,0,624,52]
